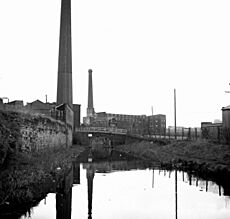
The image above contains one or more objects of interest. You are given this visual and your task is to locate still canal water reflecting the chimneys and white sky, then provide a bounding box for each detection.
[18,154,230,219]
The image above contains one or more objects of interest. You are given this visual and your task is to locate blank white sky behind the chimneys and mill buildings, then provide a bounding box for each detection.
[0,0,230,127]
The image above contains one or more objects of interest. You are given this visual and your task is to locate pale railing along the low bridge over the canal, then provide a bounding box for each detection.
[75,127,127,135]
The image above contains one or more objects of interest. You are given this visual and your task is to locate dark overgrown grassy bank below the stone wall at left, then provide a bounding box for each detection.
[0,147,84,215]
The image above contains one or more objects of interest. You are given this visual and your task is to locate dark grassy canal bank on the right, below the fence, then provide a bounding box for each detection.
[116,141,230,186]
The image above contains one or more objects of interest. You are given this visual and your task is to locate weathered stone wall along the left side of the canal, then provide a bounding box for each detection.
[0,111,72,156]
